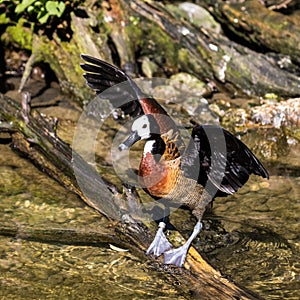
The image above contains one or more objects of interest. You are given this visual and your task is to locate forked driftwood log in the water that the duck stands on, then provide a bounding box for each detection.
[0,94,260,299]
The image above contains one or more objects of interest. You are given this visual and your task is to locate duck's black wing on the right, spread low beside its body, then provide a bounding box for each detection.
[182,125,269,197]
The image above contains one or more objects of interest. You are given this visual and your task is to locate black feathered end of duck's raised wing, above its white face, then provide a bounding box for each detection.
[80,54,146,117]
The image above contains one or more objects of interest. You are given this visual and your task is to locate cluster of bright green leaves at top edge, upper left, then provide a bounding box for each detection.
[15,0,66,24]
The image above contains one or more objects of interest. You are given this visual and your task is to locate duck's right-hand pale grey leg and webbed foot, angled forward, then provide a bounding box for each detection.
[164,221,202,267]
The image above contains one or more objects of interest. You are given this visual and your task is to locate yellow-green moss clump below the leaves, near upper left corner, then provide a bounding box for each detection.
[2,18,33,50]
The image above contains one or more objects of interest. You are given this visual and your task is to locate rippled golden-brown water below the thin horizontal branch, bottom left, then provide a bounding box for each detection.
[0,237,184,300]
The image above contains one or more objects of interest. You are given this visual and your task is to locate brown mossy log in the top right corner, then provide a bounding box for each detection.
[203,0,300,63]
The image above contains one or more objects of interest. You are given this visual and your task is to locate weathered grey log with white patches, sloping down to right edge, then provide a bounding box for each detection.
[129,0,300,96]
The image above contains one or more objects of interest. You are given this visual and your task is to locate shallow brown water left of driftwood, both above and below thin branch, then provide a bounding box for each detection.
[0,144,184,300]
